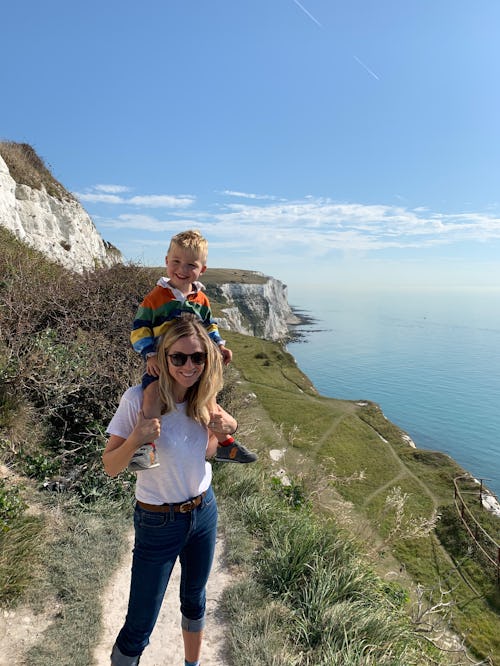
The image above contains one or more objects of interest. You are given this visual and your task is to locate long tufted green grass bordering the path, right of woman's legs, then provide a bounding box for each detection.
[216,467,441,666]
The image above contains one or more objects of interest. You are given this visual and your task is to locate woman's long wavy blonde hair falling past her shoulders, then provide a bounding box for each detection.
[158,313,222,425]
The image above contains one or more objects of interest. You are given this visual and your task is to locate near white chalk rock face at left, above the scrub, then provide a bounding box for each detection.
[0,156,122,272]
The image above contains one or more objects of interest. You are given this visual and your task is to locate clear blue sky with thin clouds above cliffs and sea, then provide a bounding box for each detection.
[0,0,500,294]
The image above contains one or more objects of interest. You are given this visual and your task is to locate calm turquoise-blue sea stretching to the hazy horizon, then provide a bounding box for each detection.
[287,287,500,498]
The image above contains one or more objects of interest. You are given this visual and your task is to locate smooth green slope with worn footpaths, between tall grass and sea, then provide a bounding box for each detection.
[226,334,500,663]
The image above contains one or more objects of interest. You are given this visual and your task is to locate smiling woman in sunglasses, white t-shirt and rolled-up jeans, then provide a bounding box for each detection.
[103,315,237,666]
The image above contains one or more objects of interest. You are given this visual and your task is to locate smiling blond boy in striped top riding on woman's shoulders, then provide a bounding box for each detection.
[129,230,257,471]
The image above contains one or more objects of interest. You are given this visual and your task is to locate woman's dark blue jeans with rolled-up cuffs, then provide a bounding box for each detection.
[116,487,217,657]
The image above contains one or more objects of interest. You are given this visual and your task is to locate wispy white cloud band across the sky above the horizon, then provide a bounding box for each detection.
[82,184,500,265]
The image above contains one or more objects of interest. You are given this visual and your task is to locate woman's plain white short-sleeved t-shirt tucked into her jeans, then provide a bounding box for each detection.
[107,386,212,504]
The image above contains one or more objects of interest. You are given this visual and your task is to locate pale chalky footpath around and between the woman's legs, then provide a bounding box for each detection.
[93,532,232,666]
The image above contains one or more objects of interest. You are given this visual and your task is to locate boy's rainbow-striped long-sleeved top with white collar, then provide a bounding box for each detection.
[130,277,224,358]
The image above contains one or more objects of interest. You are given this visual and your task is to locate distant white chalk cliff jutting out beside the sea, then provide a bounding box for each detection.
[219,273,300,340]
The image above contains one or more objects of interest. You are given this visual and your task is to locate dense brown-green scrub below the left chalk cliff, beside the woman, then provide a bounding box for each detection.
[0,228,156,501]
